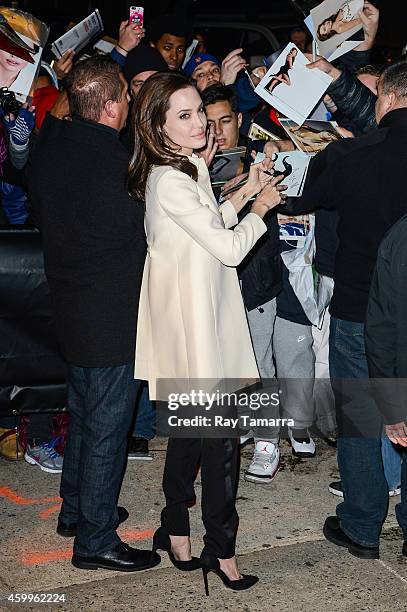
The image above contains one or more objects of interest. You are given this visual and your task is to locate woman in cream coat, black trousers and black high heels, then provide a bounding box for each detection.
[129,73,281,590]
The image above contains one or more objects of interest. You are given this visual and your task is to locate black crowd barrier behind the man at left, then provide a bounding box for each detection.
[0,226,66,418]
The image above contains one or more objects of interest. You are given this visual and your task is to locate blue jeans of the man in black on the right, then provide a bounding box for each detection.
[329,317,389,547]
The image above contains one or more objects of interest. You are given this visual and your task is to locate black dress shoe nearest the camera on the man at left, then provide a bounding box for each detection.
[72,542,161,572]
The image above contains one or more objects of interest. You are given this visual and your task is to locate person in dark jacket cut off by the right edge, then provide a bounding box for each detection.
[365,215,407,557]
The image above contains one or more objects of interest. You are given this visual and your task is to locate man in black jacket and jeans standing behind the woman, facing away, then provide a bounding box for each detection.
[29,57,160,571]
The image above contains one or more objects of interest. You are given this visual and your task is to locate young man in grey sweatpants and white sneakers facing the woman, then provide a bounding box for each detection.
[202,83,315,484]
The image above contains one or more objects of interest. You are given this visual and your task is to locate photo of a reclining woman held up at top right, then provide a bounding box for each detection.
[311,0,364,58]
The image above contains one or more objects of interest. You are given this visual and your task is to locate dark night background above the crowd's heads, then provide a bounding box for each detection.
[3,0,407,55]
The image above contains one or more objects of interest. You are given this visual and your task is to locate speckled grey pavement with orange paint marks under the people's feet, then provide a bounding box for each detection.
[0,439,407,612]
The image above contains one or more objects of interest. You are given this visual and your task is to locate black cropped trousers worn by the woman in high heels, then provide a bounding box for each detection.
[161,438,239,559]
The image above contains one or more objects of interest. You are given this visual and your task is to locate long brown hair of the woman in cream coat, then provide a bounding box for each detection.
[128,72,198,200]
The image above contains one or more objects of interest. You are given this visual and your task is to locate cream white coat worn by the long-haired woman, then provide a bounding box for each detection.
[135,156,266,400]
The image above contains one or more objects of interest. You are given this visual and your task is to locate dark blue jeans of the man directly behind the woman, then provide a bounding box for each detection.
[60,363,140,556]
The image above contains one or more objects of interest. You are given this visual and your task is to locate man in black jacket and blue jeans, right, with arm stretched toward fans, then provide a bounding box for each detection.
[294,62,407,558]
